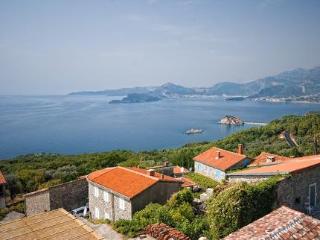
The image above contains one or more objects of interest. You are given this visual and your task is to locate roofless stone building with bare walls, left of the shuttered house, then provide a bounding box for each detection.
[25,178,88,216]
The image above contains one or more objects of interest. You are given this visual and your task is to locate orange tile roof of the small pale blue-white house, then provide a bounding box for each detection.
[193,147,247,171]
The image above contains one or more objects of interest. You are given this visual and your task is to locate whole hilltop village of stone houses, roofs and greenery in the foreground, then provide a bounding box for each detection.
[0,114,320,240]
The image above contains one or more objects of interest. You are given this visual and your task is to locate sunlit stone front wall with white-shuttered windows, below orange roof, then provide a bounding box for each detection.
[89,181,132,221]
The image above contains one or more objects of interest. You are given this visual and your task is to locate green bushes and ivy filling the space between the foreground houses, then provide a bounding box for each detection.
[113,177,281,239]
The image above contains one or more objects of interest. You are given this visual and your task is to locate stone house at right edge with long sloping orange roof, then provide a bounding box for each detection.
[227,155,320,214]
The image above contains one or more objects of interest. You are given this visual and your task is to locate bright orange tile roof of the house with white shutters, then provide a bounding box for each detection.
[87,167,180,198]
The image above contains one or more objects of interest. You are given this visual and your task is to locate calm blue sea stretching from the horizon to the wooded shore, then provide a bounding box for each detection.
[0,96,320,159]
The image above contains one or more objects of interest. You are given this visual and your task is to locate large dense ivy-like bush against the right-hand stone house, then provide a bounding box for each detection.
[207,177,281,239]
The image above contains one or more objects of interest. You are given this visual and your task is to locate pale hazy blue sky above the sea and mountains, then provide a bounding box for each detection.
[0,0,320,95]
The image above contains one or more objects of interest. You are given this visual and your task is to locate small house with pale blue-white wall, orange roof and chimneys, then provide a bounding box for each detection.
[193,144,251,181]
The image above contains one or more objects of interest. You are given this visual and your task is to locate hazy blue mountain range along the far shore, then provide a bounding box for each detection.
[71,67,320,98]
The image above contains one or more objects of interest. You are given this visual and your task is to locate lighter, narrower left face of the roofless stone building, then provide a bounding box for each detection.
[25,189,50,216]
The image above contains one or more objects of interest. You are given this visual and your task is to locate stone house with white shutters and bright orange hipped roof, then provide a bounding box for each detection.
[87,167,182,221]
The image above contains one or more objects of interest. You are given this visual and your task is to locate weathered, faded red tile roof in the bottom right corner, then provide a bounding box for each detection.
[224,206,320,240]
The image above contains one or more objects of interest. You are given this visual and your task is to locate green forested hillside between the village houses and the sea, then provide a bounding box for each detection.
[0,113,320,196]
